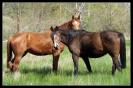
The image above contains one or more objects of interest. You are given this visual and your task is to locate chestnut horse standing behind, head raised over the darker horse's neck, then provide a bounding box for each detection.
[7,15,80,72]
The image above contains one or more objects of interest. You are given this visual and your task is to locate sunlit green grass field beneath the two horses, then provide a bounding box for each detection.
[2,41,131,85]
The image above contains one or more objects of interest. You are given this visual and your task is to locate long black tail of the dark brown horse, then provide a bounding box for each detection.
[120,34,126,68]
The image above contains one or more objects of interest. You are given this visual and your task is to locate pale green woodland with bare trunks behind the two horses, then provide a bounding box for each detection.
[2,2,130,40]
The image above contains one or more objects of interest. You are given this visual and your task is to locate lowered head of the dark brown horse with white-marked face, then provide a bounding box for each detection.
[50,26,61,49]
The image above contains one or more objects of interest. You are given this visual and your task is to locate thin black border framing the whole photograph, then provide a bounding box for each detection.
[0,0,133,88]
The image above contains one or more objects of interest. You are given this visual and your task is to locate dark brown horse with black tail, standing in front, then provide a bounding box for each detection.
[51,27,126,76]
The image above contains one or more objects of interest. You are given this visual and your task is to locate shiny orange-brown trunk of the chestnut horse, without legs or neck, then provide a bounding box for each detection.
[8,30,64,55]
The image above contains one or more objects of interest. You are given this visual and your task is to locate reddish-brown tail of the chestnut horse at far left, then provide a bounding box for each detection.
[7,38,12,68]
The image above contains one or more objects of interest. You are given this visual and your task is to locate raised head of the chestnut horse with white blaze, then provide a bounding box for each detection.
[71,15,80,30]
